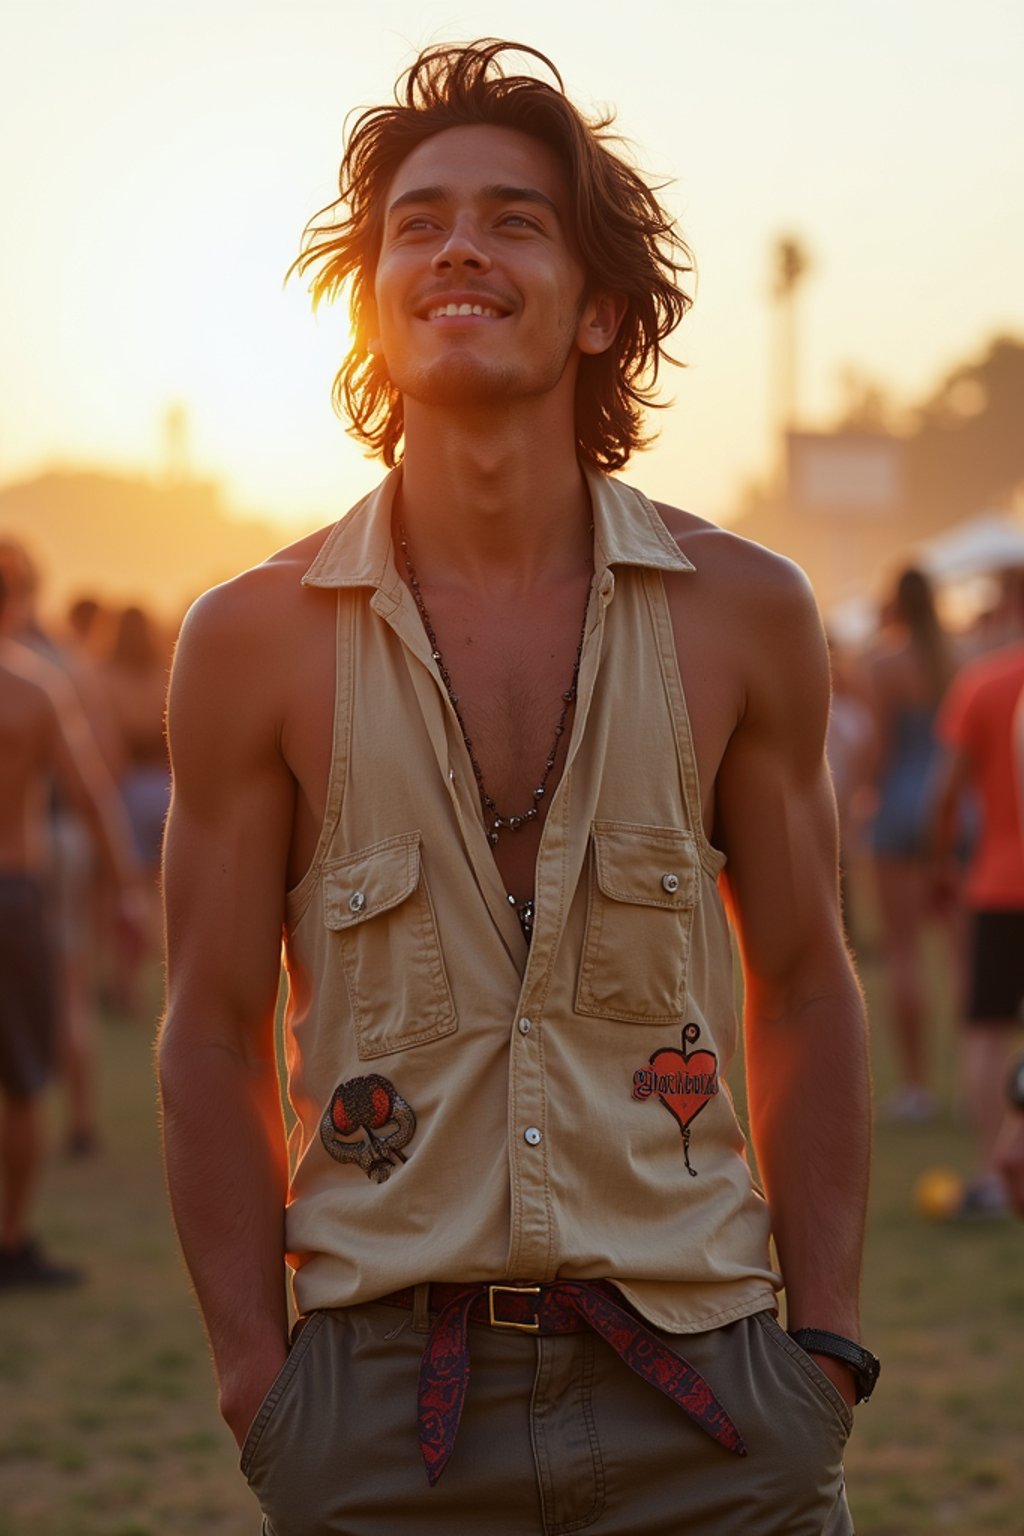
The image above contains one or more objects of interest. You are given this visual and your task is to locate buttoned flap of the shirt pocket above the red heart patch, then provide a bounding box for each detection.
[591,822,697,911]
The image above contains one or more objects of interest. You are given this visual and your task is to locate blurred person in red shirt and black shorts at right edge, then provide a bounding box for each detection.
[936,571,1024,1217]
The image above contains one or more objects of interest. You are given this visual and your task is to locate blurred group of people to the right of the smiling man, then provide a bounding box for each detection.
[827,567,1024,1218]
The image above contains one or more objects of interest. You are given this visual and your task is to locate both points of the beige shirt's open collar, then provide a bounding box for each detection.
[302,467,694,590]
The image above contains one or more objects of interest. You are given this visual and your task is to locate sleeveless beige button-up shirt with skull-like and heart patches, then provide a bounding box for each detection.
[286,472,780,1332]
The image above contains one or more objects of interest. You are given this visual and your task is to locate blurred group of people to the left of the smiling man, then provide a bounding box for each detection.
[0,539,181,1289]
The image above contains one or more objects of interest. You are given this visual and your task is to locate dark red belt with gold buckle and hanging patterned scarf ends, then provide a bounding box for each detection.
[378,1279,746,1487]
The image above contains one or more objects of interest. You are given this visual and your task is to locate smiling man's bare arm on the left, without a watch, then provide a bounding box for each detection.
[160,578,293,1442]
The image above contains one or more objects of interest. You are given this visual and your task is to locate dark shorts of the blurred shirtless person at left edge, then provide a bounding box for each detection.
[0,874,57,1098]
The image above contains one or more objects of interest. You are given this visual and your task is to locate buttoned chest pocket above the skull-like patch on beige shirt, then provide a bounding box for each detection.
[324,833,457,1061]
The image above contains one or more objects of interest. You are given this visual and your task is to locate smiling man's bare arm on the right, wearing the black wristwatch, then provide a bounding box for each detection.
[718,567,870,1401]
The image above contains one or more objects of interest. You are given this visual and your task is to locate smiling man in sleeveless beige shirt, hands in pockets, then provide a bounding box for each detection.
[161,43,877,1536]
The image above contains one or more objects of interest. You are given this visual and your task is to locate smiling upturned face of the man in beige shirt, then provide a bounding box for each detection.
[373,126,606,410]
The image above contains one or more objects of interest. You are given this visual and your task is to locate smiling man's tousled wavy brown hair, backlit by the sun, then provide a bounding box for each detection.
[289,38,692,470]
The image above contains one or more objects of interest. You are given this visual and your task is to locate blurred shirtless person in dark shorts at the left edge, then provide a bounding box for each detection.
[0,565,141,1292]
